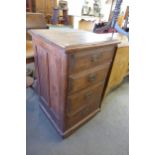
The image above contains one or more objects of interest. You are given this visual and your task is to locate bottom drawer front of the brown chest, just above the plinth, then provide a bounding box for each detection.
[67,104,99,128]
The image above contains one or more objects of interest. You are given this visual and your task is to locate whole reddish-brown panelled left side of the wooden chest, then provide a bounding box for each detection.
[34,38,67,132]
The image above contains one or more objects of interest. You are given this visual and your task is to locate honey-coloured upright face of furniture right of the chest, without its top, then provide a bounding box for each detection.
[106,46,129,94]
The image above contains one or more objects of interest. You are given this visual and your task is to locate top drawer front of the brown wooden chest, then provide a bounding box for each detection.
[69,46,115,74]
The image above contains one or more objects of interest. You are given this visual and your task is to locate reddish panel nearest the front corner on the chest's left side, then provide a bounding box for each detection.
[49,47,65,118]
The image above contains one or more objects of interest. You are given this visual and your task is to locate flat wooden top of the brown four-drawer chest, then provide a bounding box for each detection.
[29,28,119,49]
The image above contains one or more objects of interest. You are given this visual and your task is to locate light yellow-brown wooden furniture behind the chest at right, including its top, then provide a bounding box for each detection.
[105,34,129,95]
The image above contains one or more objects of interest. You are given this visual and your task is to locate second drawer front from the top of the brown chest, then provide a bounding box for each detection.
[68,64,110,94]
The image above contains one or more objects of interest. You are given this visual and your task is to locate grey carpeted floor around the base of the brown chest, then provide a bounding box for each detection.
[26,80,129,155]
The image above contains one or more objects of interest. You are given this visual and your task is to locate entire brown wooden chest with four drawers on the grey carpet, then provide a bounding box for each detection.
[29,29,118,137]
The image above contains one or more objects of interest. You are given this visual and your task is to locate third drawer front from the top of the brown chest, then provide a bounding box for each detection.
[67,83,103,114]
